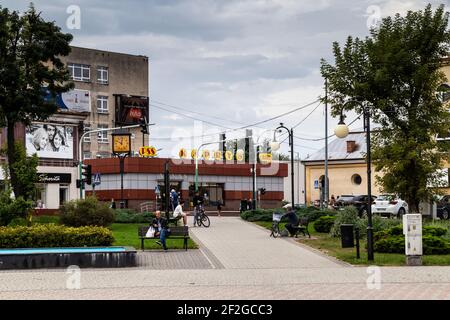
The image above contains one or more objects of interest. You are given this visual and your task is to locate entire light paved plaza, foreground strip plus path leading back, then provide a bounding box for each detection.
[0,217,450,300]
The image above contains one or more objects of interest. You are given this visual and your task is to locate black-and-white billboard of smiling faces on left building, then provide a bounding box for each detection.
[25,123,73,159]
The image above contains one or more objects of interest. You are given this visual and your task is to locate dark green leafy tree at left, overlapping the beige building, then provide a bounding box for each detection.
[0,5,73,199]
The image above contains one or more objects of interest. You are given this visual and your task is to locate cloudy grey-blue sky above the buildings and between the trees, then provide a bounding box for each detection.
[0,0,448,158]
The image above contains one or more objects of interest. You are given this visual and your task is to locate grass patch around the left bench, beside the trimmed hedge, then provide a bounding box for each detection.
[109,223,198,250]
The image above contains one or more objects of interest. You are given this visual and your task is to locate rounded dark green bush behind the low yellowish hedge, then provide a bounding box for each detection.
[60,197,114,227]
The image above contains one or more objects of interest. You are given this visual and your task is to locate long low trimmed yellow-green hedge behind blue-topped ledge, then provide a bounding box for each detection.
[0,224,114,248]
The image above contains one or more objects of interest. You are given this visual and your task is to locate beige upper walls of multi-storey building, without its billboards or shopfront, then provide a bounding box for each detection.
[62,47,149,159]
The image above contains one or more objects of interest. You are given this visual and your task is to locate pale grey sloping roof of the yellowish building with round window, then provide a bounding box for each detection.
[302,132,367,162]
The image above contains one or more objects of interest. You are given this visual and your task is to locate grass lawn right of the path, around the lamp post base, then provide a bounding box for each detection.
[255,221,450,266]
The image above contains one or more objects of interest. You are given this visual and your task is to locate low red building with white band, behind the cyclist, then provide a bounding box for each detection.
[86,157,288,211]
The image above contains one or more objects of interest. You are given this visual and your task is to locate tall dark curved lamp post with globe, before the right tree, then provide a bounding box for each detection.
[334,100,374,261]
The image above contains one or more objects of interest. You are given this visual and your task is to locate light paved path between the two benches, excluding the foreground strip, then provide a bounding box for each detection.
[188,217,343,269]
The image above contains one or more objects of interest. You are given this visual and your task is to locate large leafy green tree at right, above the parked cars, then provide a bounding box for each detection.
[321,4,450,212]
